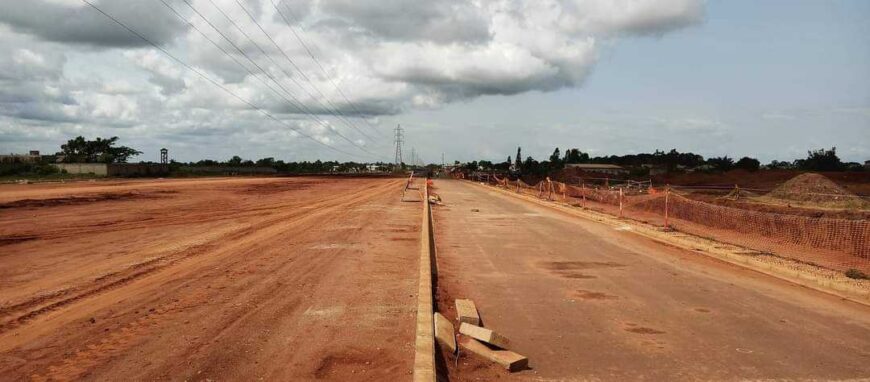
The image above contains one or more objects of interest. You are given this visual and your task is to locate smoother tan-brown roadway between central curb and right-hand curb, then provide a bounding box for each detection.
[434,180,870,381]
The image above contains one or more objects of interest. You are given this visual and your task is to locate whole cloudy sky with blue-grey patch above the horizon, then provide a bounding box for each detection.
[0,0,870,163]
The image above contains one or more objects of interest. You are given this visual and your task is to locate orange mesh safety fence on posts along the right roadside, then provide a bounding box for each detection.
[491,179,870,273]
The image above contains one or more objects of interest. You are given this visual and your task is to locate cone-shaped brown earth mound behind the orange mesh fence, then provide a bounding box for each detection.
[768,173,861,203]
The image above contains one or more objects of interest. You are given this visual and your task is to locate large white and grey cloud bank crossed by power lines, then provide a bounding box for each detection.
[0,0,703,159]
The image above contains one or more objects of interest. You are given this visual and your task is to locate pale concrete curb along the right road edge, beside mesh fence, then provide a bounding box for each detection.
[474,182,870,306]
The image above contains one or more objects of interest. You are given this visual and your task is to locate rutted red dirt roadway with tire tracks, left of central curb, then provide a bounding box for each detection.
[0,178,420,381]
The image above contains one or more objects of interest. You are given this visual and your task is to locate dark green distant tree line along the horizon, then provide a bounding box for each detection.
[0,136,865,177]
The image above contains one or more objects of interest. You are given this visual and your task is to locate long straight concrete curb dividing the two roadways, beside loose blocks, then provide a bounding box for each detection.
[414,181,436,382]
